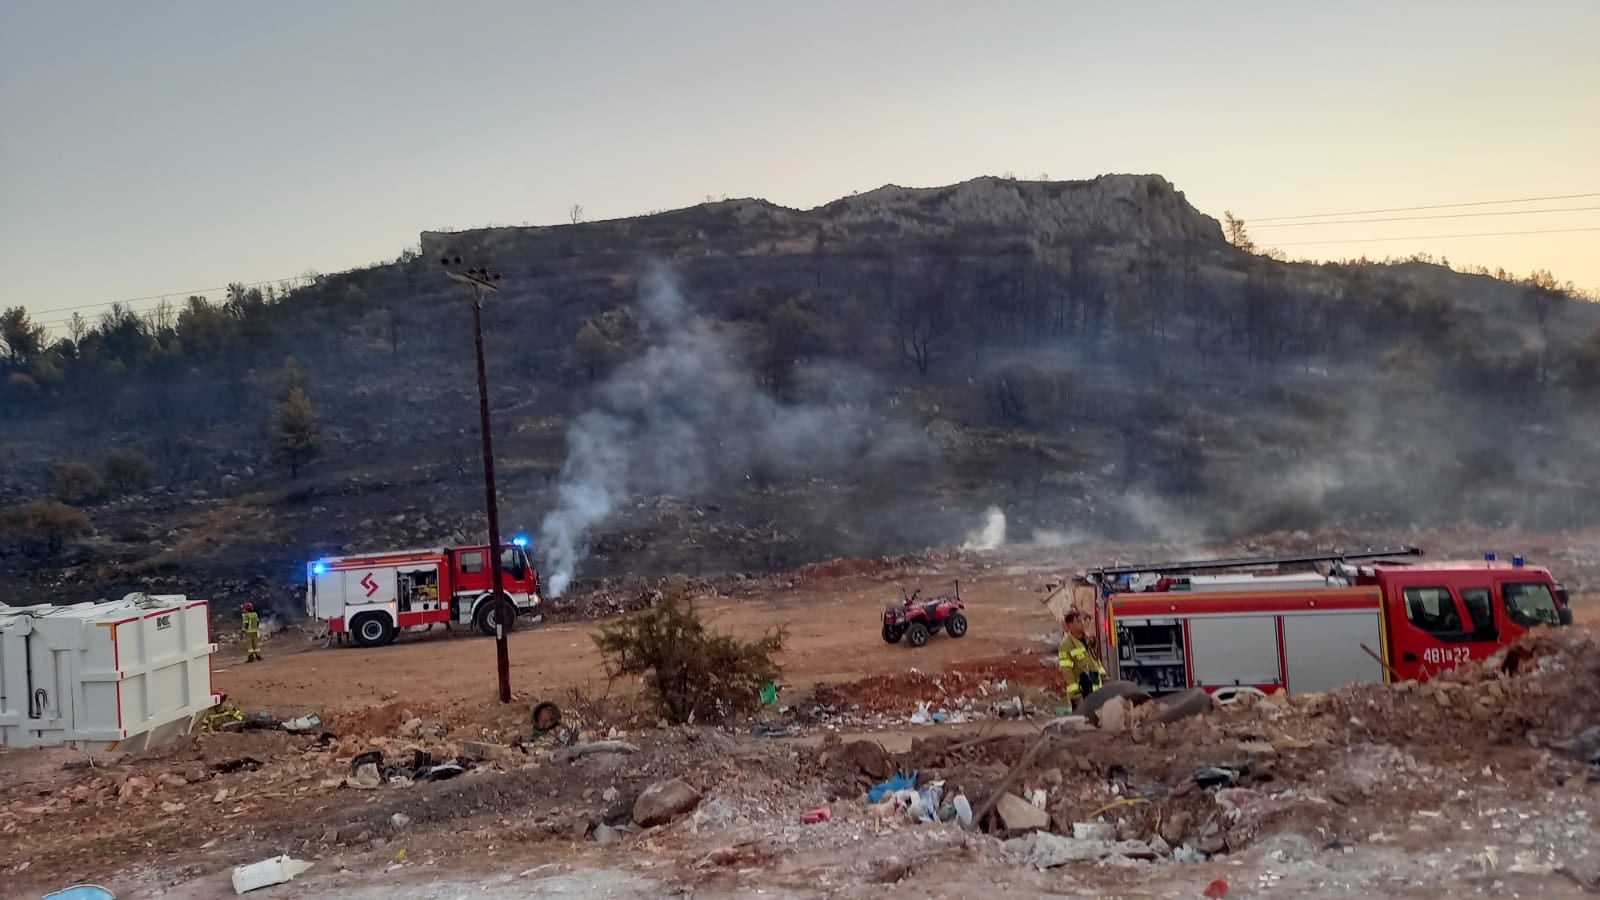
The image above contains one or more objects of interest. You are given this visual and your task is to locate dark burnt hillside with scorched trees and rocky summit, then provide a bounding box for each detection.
[0,176,1600,605]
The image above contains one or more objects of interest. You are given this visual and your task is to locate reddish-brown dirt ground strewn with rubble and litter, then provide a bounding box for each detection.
[0,536,1600,898]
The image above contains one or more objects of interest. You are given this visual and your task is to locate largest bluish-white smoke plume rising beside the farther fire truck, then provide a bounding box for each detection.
[539,261,928,597]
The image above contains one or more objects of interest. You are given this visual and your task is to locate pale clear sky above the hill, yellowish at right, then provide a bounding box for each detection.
[0,0,1600,323]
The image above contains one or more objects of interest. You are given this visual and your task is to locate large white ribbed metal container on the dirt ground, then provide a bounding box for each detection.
[0,594,219,749]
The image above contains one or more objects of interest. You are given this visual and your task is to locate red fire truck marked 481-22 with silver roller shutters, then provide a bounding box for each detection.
[1080,548,1571,697]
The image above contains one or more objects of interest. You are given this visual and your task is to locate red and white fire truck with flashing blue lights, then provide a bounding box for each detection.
[306,538,539,647]
